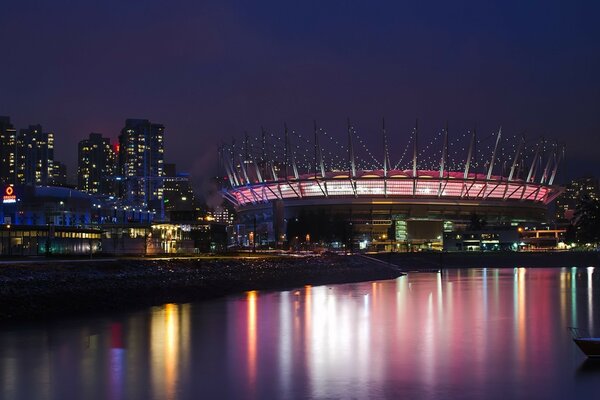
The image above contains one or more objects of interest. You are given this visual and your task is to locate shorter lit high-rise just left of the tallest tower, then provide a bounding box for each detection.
[77,133,116,196]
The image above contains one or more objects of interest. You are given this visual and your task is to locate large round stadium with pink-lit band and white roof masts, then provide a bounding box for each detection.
[220,123,564,251]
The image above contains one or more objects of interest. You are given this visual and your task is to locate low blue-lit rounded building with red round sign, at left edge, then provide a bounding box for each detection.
[0,185,154,255]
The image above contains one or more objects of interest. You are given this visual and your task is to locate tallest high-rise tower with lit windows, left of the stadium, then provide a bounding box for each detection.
[118,119,165,211]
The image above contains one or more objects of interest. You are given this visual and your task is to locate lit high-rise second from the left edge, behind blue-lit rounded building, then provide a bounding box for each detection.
[16,125,54,186]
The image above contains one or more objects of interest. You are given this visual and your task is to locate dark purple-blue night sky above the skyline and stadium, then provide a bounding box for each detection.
[0,0,600,188]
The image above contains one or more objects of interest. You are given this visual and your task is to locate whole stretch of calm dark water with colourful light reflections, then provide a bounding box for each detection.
[0,268,600,400]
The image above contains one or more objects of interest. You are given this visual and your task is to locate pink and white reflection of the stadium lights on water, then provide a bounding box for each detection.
[227,268,592,398]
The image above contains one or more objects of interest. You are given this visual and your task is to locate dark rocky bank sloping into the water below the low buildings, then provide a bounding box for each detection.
[0,255,402,321]
